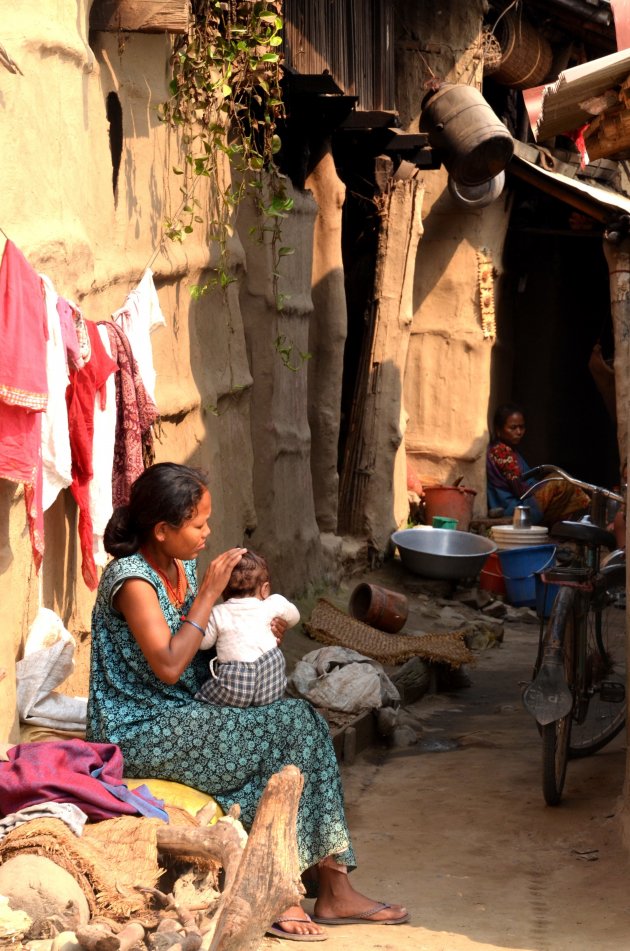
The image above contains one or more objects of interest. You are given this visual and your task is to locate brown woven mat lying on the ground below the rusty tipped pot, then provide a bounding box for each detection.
[304,598,474,669]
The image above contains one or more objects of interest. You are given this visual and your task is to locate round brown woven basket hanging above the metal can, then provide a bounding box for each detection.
[492,11,553,89]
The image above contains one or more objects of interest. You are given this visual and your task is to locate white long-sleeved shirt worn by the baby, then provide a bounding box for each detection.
[200,594,300,663]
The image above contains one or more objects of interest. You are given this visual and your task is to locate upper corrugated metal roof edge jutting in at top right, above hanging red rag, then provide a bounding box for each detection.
[526,49,630,141]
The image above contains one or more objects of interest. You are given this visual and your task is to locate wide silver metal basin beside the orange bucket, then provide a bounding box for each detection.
[392,525,497,580]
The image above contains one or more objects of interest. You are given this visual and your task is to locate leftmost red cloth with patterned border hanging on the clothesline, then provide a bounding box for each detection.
[0,241,48,571]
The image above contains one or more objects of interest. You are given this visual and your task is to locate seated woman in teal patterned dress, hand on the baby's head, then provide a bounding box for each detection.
[86,463,408,941]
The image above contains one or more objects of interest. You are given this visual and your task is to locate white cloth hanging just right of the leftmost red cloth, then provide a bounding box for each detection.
[39,274,72,512]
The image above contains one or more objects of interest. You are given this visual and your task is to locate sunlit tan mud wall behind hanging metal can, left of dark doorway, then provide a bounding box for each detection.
[397,0,509,512]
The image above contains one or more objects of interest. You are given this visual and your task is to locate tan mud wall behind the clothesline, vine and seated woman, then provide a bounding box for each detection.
[0,0,320,741]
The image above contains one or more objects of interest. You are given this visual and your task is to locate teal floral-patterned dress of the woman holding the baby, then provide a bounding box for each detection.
[86,554,355,869]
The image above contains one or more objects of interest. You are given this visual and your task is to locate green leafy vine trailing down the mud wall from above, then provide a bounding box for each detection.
[160,0,293,310]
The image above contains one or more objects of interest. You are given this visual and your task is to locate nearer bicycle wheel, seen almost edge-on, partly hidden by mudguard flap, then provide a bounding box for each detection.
[541,588,575,806]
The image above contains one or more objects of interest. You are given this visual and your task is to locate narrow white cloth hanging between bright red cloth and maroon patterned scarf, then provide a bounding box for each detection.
[89,325,116,568]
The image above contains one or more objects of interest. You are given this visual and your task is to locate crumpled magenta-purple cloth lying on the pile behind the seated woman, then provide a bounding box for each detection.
[0,739,162,821]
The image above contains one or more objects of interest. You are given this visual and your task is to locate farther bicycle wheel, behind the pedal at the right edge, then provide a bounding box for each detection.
[569,585,626,758]
